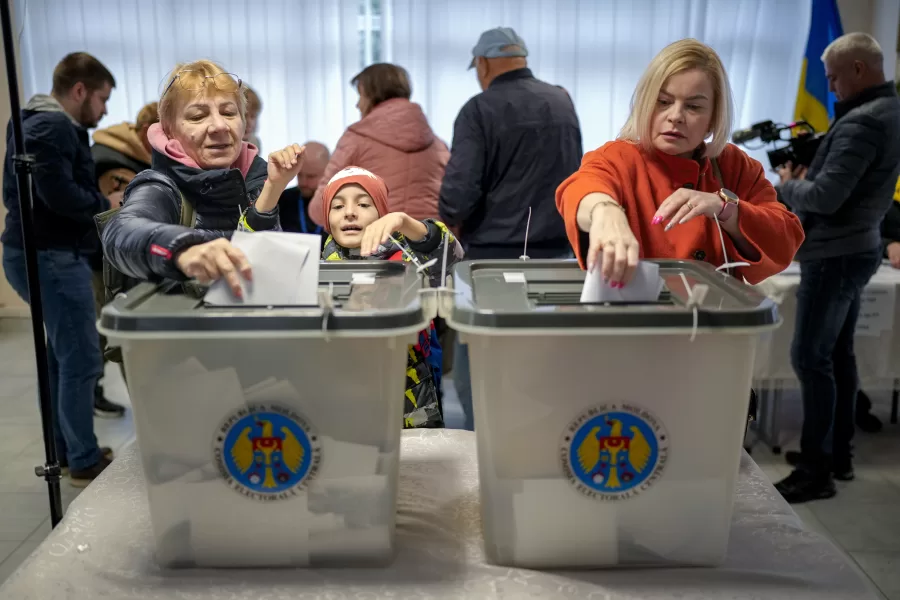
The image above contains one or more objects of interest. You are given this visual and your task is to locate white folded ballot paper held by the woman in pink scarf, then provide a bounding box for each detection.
[205,231,321,306]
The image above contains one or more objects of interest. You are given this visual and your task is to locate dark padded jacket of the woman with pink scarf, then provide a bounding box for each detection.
[103,150,279,280]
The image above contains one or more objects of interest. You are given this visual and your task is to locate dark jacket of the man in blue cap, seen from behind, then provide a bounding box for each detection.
[438,69,582,256]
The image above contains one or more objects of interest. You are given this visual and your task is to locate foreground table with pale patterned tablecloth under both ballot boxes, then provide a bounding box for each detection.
[0,430,877,600]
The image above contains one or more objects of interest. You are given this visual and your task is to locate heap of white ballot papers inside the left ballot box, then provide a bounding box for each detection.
[138,358,396,567]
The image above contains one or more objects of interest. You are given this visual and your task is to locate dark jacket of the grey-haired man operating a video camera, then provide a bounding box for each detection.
[781,82,900,261]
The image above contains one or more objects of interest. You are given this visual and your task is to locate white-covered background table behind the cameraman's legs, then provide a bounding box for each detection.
[754,263,900,453]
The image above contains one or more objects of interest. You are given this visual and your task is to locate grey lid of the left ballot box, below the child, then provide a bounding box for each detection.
[99,261,426,337]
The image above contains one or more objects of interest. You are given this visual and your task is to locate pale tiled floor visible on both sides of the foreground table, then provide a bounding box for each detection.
[0,319,900,600]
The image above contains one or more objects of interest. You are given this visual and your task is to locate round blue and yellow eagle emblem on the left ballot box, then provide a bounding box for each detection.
[214,404,322,500]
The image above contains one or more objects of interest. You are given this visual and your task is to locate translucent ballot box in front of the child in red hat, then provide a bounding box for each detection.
[100,261,429,567]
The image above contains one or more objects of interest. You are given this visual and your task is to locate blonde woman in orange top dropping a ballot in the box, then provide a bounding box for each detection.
[556,39,803,287]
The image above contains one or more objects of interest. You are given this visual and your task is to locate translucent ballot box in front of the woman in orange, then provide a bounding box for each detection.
[441,260,779,568]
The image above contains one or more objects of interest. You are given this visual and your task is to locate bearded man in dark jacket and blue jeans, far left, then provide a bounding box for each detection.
[0,52,121,487]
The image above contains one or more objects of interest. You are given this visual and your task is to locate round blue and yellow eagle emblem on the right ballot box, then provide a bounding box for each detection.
[560,404,669,500]
